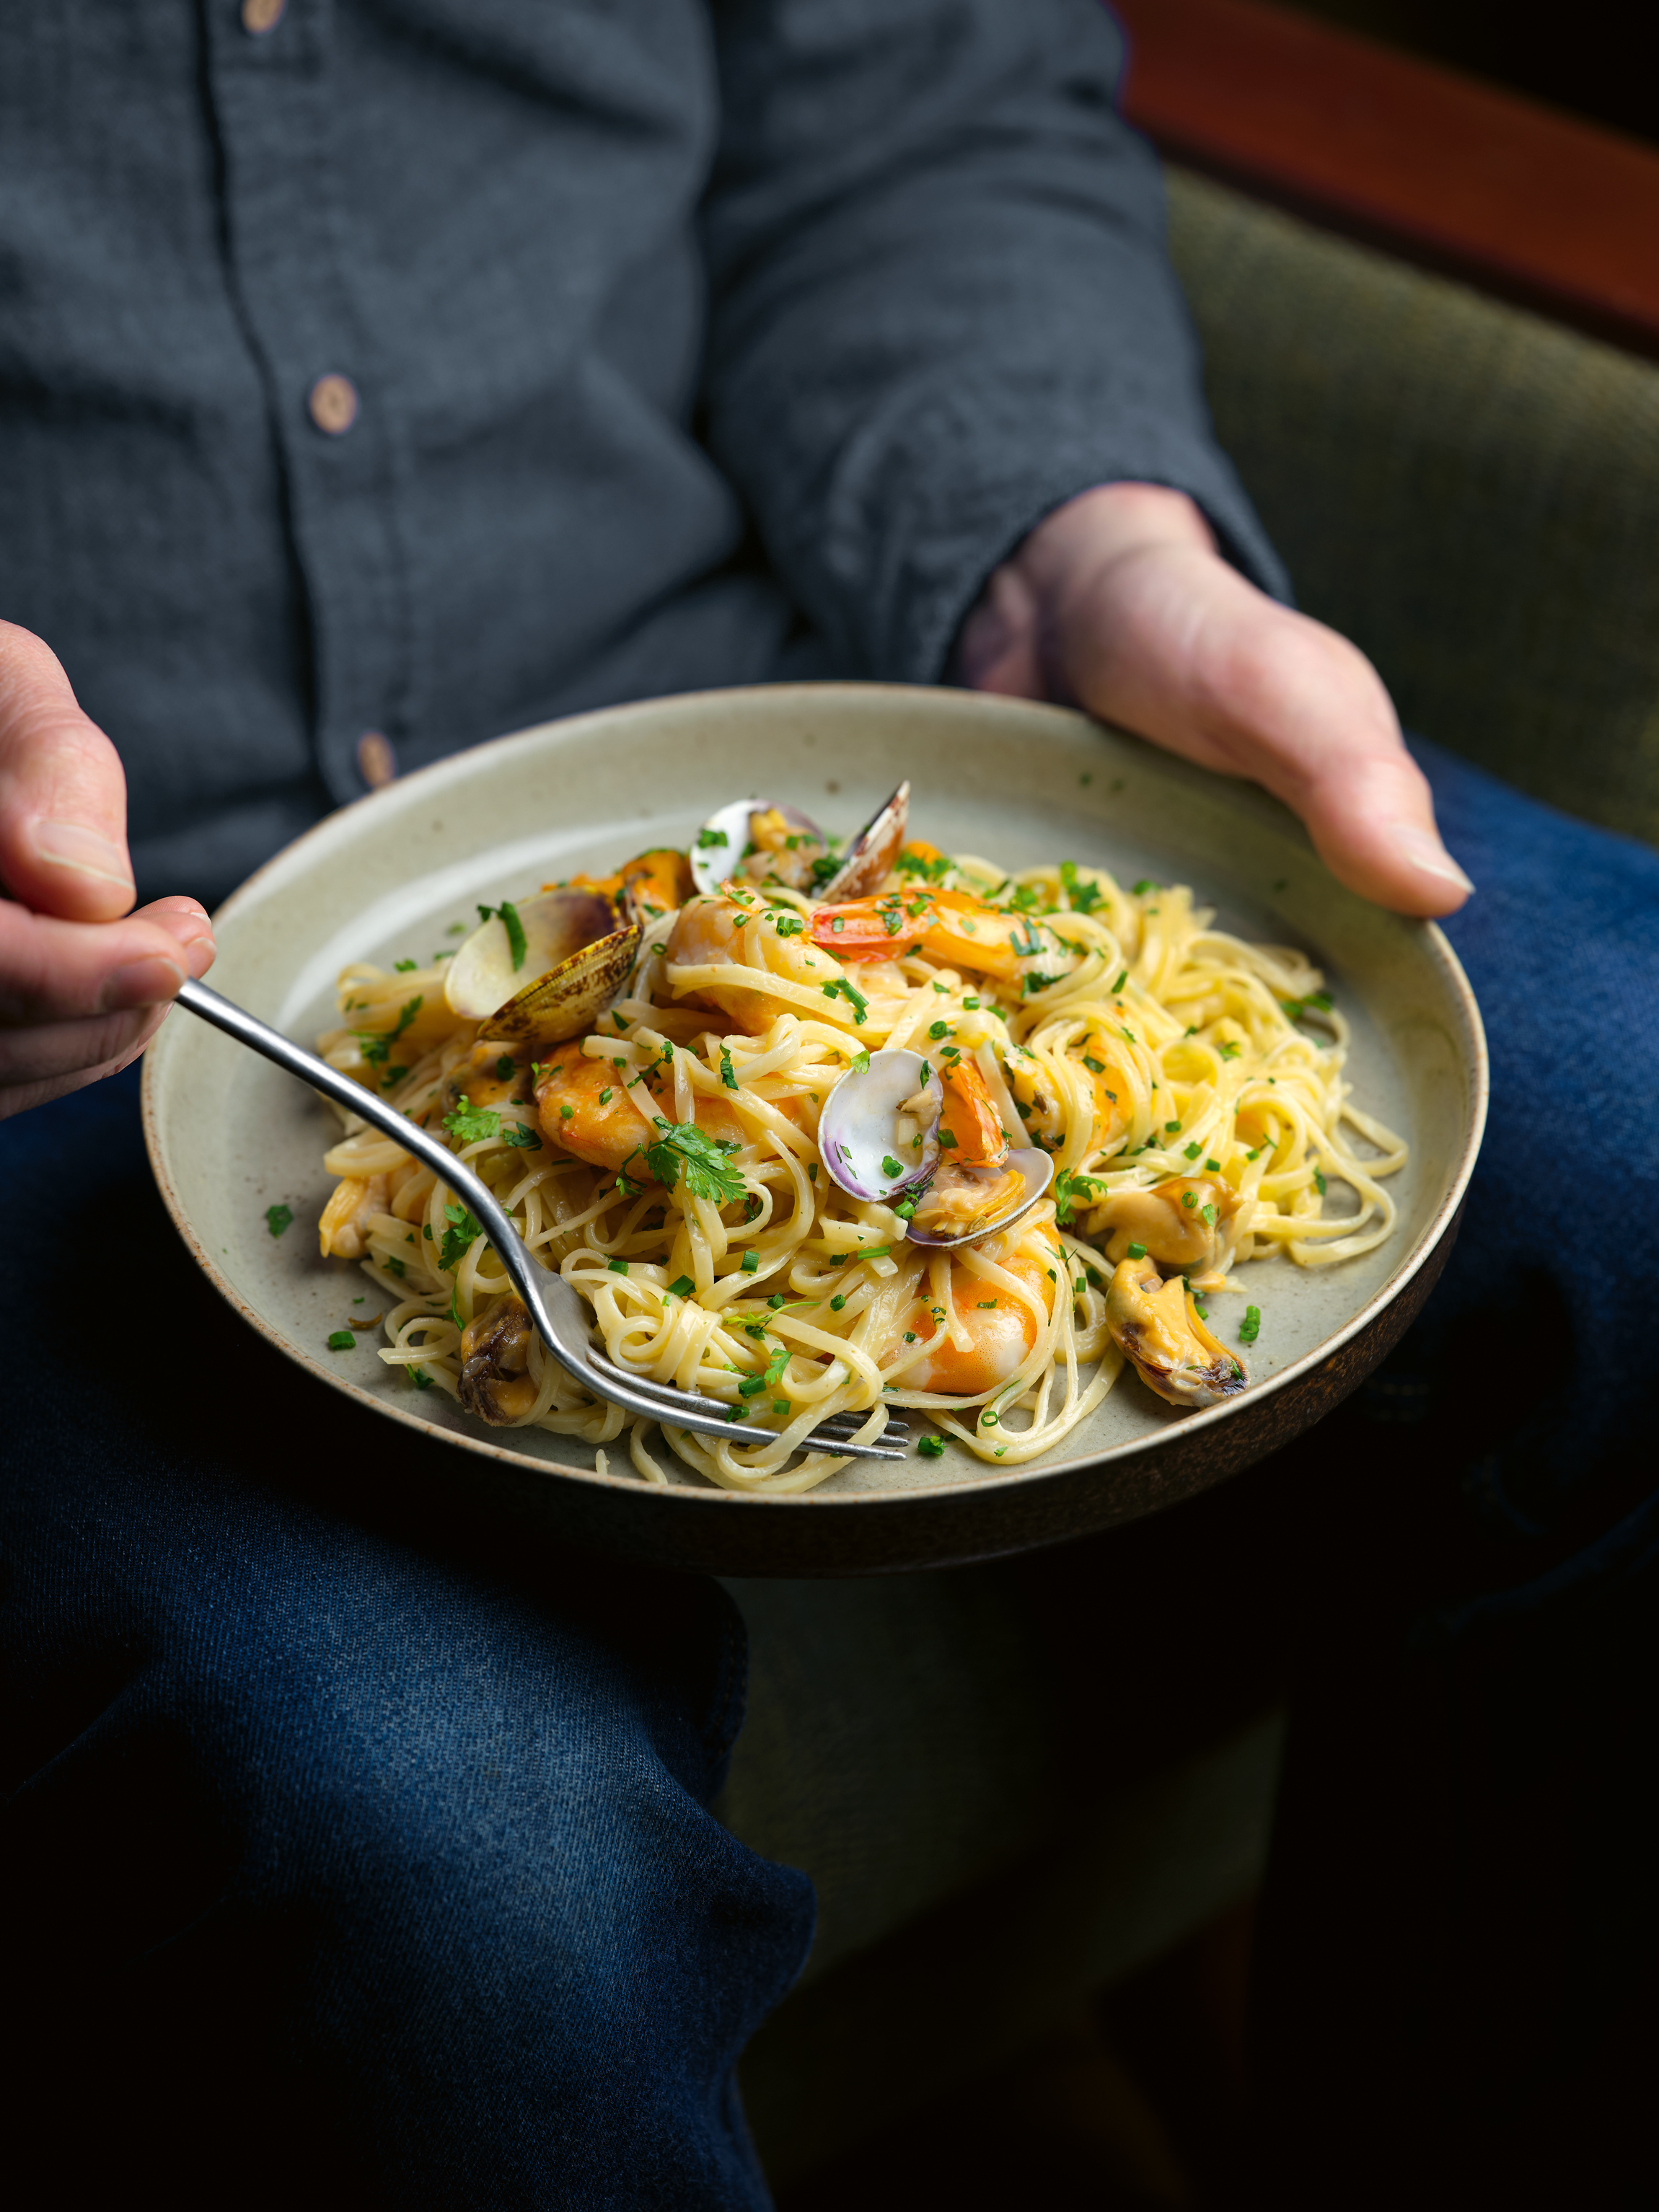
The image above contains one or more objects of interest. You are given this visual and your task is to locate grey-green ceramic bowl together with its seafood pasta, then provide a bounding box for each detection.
[144,684,1487,1575]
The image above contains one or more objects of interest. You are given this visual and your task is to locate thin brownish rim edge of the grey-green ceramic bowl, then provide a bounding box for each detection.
[139,682,1491,1513]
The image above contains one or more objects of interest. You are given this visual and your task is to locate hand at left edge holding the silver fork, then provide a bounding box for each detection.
[0,622,212,1117]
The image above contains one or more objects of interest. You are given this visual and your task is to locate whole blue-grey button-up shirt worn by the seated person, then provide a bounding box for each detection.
[0,0,1276,898]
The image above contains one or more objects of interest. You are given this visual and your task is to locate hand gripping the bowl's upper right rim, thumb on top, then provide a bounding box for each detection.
[951,485,1473,914]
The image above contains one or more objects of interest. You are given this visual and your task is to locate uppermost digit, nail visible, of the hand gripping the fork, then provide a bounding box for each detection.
[0,622,133,922]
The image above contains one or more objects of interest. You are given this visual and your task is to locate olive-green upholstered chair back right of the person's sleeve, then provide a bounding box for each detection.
[1170,170,1659,843]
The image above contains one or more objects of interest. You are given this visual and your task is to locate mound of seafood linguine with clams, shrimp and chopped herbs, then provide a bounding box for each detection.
[319,788,1407,1491]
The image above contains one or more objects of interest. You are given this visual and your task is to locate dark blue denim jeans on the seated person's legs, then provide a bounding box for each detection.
[0,748,1659,2208]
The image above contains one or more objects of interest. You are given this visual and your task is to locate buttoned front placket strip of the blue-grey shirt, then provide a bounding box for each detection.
[206,0,411,801]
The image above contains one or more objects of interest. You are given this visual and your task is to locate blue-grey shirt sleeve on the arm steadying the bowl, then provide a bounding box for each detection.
[703,0,1288,684]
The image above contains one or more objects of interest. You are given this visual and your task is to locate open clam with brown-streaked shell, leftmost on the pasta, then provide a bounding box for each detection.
[444,887,643,1044]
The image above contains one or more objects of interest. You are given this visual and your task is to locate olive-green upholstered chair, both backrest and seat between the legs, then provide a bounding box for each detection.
[719,175,1659,2183]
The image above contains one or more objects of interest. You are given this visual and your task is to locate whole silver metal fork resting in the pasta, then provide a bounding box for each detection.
[177,982,909,1460]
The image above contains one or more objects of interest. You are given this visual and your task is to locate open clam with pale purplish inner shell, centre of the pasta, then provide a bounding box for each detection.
[819,1051,1055,1248]
